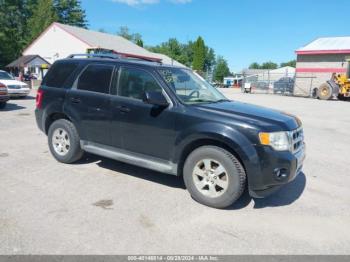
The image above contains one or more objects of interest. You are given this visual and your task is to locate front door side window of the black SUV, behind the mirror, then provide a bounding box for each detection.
[118,68,162,99]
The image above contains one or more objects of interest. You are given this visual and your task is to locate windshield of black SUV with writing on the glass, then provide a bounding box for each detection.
[159,68,227,104]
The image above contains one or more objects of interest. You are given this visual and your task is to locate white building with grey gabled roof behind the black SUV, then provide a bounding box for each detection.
[17,23,184,77]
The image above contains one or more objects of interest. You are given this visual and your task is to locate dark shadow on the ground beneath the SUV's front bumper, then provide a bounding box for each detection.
[229,172,306,210]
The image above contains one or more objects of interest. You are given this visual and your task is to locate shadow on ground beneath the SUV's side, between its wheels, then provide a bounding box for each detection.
[76,154,186,189]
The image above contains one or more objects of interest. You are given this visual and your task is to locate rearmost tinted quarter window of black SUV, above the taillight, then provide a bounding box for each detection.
[43,62,79,88]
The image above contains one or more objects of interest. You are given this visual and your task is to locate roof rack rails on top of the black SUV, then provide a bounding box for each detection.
[68,51,162,64]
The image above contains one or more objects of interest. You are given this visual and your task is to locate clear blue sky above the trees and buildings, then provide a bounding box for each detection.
[82,0,350,72]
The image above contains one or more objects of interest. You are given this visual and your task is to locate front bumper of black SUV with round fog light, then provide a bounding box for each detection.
[248,144,305,198]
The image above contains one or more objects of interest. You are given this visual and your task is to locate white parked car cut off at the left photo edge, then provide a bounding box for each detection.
[0,70,30,97]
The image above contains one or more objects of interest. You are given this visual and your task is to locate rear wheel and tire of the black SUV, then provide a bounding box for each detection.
[48,119,84,164]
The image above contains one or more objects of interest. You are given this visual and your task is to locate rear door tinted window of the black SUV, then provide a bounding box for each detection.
[78,65,113,94]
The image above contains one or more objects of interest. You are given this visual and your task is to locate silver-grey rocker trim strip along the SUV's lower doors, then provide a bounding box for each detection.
[80,140,177,175]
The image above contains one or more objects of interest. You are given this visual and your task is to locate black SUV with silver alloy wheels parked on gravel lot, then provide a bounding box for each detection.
[35,53,304,208]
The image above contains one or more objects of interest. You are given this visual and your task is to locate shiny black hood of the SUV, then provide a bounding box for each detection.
[197,101,301,132]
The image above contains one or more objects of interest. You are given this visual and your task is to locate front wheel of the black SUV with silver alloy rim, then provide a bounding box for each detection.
[183,146,246,208]
